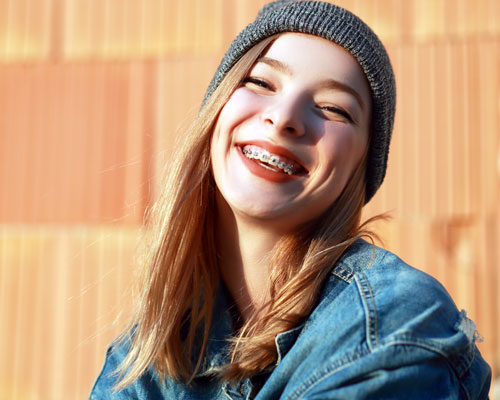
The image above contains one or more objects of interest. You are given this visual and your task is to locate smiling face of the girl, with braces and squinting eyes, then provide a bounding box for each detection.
[211,33,371,230]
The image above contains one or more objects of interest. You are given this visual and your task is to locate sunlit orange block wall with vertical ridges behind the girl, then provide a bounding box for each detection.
[0,0,500,400]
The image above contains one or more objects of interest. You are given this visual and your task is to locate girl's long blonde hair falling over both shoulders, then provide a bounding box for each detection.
[116,35,376,390]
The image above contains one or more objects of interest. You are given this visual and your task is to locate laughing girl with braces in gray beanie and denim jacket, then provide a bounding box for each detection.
[91,0,490,399]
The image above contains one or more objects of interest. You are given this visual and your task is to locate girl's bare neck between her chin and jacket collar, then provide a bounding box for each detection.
[216,194,288,321]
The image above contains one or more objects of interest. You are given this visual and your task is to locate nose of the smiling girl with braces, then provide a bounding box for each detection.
[262,96,306,137]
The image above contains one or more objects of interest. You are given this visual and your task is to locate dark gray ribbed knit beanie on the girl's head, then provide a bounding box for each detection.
[205,0,396,202]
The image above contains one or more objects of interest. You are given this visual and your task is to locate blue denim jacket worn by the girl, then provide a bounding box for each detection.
[90,240,491,400]
